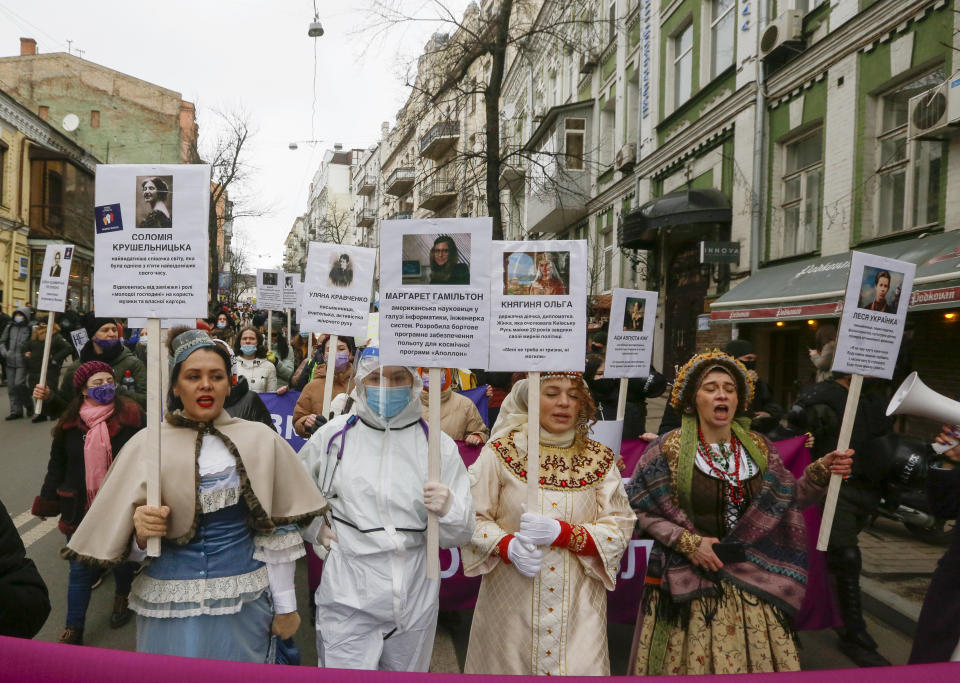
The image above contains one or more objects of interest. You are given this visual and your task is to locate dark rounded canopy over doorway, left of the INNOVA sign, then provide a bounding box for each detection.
[617,188,732,249]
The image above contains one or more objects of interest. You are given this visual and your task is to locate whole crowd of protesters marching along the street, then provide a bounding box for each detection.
[0,280,960,675]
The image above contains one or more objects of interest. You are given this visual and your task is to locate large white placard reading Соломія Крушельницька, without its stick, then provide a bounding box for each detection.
[93,164,210,318]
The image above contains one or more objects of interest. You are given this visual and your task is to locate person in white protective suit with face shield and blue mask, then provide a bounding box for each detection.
[300,347,474,671]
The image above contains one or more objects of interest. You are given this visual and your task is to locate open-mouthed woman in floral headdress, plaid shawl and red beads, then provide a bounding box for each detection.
[627,351,852,675]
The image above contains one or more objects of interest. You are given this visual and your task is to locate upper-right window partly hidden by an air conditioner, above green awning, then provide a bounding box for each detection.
[873,69,947,237]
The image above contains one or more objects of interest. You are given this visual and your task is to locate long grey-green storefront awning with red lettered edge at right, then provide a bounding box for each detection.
[710,230,960,323]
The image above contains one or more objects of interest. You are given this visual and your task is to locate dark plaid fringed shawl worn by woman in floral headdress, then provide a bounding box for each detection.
[626,416,807,674]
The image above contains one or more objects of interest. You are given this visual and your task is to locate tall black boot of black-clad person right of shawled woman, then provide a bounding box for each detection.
[827,546,890,667]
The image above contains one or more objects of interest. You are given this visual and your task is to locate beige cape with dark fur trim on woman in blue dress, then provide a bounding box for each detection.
[60,411,328,567]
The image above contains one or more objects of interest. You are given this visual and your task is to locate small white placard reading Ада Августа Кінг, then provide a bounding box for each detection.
[603,288,657,377]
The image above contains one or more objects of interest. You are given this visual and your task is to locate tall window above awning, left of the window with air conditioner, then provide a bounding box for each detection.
[770,128,823,258]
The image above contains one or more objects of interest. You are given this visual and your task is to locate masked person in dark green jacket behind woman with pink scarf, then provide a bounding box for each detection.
[33,312,147,417]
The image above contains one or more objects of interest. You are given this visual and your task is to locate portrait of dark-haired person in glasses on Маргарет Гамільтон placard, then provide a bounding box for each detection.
[401,233,470,285]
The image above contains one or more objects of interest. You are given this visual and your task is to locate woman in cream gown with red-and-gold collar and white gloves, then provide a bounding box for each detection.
[462,373,635,676]
